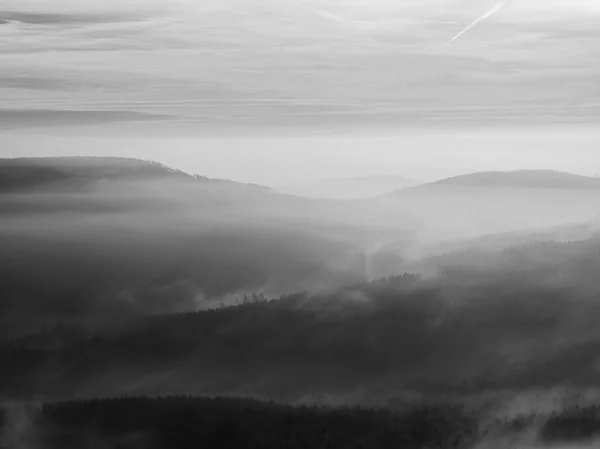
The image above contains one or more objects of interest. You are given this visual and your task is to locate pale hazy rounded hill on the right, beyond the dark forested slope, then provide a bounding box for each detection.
[370,170,600,242]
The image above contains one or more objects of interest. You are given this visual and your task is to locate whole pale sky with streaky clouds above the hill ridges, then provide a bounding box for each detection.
[0,0,600,185]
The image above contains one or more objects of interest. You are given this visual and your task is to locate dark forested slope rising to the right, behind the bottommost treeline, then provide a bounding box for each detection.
[0,239,600,401]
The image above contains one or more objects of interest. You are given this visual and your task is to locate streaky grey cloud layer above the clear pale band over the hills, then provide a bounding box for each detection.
[0,0,600,129]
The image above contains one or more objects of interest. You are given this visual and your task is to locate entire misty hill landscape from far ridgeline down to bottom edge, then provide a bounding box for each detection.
[0,157,600,449]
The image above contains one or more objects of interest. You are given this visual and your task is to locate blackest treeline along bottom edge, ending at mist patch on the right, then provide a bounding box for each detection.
[0,397,478,449]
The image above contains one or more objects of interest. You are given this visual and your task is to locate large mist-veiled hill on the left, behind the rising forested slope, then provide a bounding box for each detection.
[0,158,418,338]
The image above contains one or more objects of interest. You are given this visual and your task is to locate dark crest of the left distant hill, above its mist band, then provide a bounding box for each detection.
[0,157,270,193]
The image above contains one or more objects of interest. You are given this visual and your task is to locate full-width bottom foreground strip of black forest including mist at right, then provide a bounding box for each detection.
[0,396,600,449]
